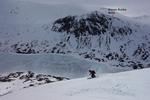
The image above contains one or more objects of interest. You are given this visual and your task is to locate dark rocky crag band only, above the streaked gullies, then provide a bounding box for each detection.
[52,11,132,38]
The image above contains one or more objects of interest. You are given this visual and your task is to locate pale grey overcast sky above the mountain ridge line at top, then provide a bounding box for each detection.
[14,0,150,16]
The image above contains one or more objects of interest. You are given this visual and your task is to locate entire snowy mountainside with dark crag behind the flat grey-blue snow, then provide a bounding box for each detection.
[0,0,150,69]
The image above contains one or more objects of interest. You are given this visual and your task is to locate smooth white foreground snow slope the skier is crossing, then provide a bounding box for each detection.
[0,68,150,100]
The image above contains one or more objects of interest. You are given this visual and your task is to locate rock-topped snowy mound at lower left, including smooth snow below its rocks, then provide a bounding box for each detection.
[0,71,68,96]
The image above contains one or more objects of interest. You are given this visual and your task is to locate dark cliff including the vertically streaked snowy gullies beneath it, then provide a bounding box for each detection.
[51,11,133,49]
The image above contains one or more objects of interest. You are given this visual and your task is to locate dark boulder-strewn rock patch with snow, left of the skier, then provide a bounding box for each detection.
[0,71,69,88]
